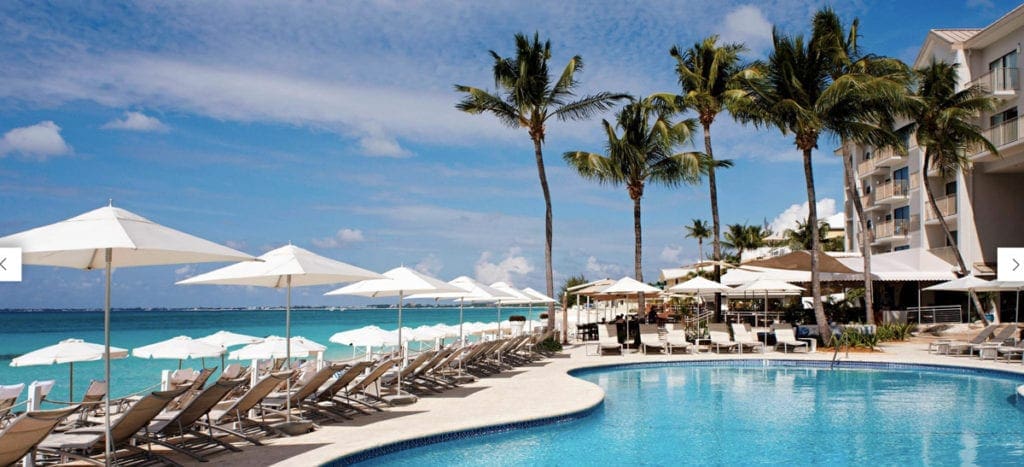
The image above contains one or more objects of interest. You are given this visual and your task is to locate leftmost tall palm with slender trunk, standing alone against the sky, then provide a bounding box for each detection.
[455,33,627,329]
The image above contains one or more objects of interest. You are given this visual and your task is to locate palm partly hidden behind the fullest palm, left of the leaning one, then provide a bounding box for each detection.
[812,7,909,324]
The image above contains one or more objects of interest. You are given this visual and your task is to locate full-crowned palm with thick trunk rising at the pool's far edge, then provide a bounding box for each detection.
[733,24,888,342]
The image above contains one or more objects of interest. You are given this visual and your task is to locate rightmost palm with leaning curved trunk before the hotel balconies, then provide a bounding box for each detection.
[909,61,999,324]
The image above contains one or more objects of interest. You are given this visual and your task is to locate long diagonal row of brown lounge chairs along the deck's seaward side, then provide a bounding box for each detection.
[0,332,551,466]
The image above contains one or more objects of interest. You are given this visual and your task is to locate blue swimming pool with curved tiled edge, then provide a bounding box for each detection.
[339,360,1024,465]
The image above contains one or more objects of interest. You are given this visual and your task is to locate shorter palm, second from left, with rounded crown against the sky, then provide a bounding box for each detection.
[563,99,703,310]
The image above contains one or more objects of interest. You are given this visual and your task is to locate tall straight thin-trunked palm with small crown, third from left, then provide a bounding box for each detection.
[669,36,746,320]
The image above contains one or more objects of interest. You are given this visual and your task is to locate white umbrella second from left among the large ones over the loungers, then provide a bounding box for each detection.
[178,245,381,423]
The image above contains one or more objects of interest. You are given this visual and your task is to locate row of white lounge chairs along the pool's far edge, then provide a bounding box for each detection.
[596,323,814,355]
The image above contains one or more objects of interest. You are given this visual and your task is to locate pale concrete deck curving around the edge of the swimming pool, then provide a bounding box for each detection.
[184,340,1024,466]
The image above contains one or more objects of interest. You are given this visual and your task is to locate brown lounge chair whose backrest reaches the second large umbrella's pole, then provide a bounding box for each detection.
[198,371,292,445]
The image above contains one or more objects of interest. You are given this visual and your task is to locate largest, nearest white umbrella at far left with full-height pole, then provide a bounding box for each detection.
[0,205,255,462]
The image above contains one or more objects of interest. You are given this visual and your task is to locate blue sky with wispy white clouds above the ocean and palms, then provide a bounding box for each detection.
[0,0,1016,307]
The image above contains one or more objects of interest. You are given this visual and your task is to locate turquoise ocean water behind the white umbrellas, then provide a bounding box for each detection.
[0,307,542,400]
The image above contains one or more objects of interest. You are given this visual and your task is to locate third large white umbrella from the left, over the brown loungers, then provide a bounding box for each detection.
[324,266,465,395]
